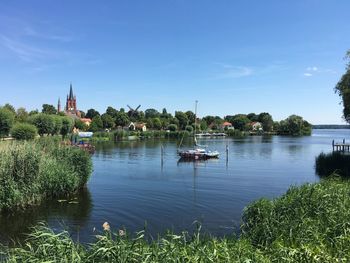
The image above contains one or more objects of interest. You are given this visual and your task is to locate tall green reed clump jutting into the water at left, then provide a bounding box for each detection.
[0,138,92,210]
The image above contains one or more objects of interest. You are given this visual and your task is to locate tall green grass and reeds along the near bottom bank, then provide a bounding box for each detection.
[2,178,350,262]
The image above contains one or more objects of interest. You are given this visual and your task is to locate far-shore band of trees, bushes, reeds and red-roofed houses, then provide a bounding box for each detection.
[0,103,312,144]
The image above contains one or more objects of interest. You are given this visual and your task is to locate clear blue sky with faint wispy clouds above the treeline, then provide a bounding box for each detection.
[0,0,350,124]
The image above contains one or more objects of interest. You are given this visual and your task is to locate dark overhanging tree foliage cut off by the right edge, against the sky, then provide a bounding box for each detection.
[334,50,350,123]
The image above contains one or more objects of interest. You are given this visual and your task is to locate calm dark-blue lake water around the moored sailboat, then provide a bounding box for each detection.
[0,130,350,245]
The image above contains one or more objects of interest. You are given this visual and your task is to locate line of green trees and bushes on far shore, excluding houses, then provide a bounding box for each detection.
[0,104,311,139]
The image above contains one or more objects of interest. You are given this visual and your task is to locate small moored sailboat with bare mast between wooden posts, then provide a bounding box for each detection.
[178,100,219,160]
